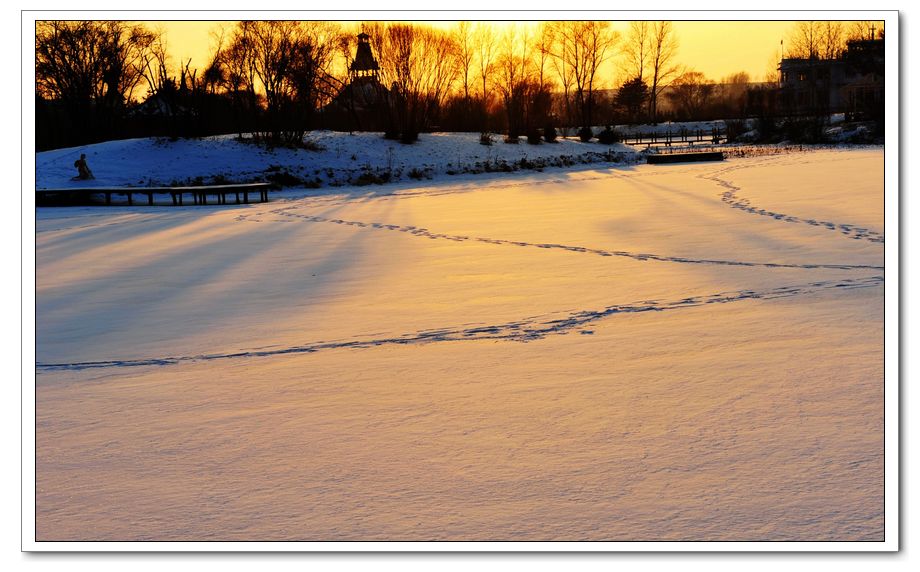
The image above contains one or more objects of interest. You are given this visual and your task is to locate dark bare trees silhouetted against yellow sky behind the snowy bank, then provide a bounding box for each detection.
[35,21,874,150]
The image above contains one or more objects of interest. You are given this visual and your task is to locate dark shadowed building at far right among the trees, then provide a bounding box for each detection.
[779,35,885,115]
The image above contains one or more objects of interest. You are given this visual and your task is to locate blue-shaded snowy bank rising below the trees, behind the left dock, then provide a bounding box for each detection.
[36,131,641,189]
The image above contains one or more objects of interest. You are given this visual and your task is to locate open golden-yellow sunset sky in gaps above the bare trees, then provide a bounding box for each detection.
[144,21,856,81]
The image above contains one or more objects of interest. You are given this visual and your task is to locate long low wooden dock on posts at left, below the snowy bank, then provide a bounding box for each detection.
[35,183,272,206]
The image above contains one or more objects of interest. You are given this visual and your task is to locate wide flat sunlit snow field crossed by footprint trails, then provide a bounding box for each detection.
[36,143,884,541]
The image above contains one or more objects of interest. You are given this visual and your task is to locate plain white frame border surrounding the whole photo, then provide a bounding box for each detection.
[21,6,902,553]
